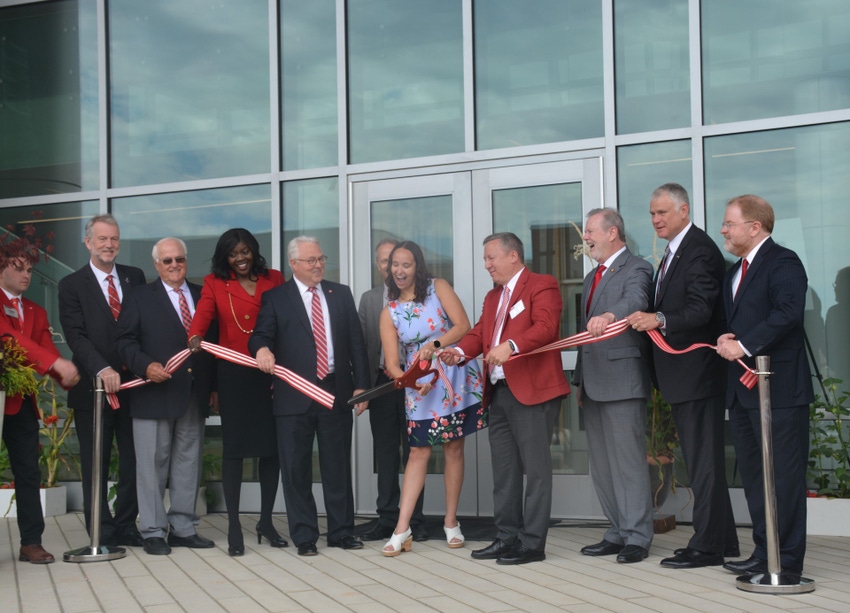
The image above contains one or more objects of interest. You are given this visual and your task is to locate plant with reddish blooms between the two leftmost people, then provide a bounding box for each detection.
[36,377,79,487]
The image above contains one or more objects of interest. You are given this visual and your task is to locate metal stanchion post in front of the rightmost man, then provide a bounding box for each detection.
[737,355,815,594]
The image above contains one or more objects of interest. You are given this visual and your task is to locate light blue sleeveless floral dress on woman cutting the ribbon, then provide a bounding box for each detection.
[387,280,487,447]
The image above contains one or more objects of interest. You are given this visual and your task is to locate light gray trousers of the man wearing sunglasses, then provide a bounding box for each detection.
[133,401,204,538]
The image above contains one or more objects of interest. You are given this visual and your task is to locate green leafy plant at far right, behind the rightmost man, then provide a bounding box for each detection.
[809,378,850,498]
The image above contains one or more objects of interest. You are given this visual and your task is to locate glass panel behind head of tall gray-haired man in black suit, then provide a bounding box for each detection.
[617,140,693,266]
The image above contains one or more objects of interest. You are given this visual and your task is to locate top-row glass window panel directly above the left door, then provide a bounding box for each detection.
[348,0,464,164]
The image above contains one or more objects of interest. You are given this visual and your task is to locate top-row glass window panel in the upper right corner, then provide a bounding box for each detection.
[700,0,850,124]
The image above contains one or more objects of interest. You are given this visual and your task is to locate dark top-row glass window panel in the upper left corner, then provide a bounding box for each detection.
[0,0,99,198]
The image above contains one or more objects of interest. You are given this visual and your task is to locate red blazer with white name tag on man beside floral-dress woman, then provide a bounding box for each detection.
[458,268,570,407]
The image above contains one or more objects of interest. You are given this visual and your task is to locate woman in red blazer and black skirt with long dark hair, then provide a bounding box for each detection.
[189,228,289,556]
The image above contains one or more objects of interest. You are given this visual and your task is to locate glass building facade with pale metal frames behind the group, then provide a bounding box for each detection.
[0,0,850,517]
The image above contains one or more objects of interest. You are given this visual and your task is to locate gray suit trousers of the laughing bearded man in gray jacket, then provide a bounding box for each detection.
[582,396,653,549]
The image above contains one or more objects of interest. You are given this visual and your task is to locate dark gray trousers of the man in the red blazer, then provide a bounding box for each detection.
[488,385,561,551]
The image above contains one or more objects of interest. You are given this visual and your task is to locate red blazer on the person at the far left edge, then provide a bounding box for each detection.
[0,291,59,415]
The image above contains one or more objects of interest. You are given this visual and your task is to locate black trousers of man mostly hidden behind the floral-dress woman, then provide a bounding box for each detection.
[369,372,425,528]
